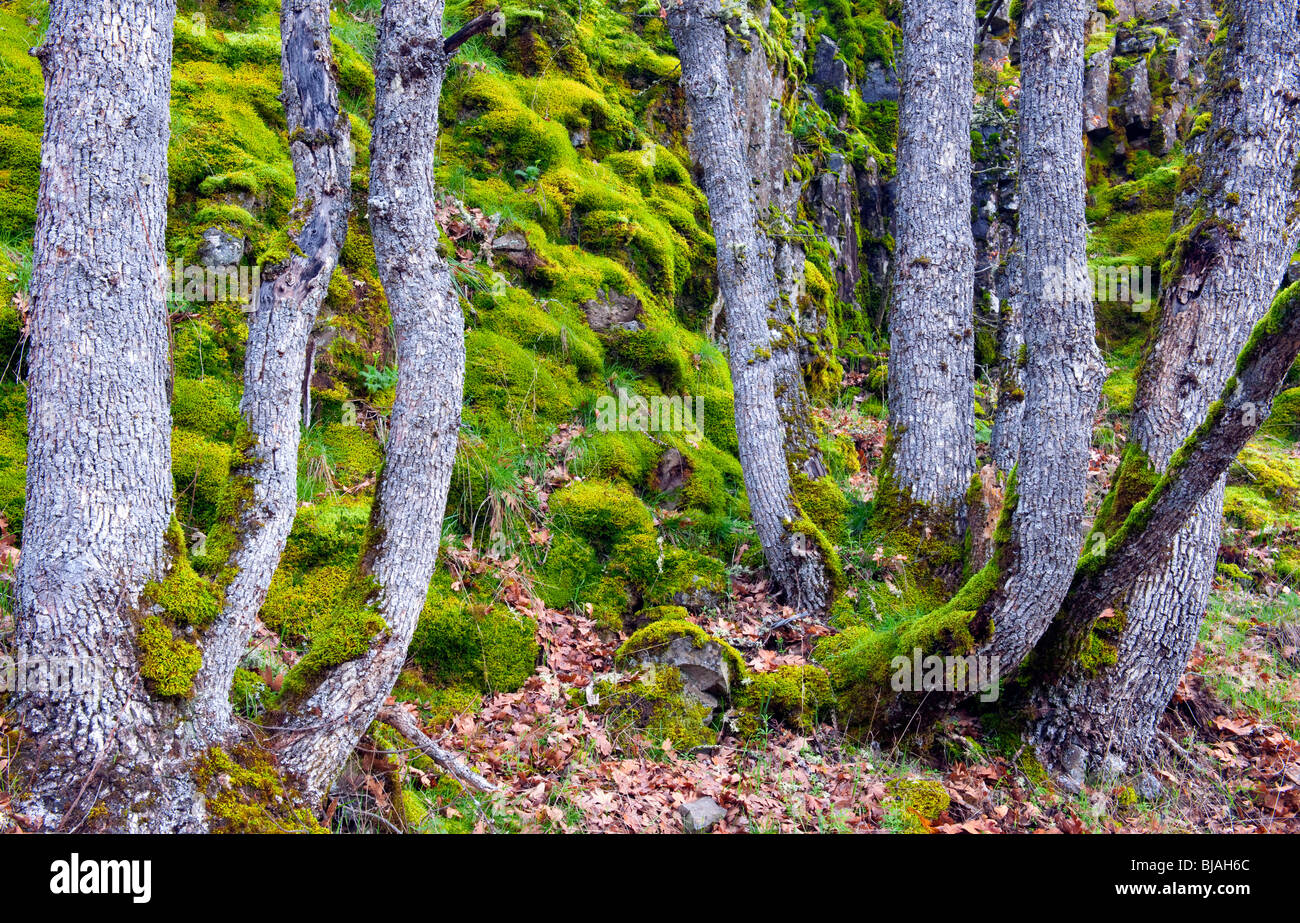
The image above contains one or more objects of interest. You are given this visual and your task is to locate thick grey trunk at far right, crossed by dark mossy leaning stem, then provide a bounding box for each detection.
[1036,0,1300,781]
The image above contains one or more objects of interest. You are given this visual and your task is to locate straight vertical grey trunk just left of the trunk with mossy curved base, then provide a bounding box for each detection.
[889,0,975,520]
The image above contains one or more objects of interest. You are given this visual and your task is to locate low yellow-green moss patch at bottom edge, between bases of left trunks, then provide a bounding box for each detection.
[194,746,325,833]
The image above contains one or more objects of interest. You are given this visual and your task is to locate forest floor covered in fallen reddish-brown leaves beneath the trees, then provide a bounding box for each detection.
[327,405,1300,833]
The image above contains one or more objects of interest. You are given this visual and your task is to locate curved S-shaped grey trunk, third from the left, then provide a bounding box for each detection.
[276,0,465,800]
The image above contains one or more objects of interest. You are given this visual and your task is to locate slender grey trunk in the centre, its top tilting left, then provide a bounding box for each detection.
[668,0,832,621]
